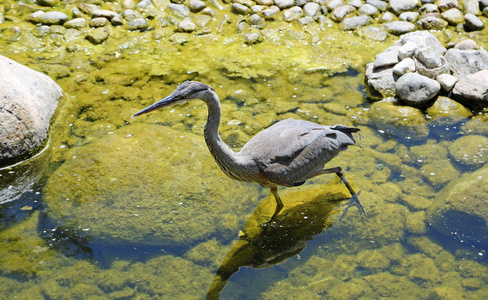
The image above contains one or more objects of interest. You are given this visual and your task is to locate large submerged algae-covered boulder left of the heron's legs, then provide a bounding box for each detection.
[43,124,258,247]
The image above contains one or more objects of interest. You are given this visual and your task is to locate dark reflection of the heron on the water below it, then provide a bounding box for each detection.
[207,185,348,299]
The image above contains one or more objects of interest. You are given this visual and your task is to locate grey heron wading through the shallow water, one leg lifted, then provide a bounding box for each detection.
[132,81,366,220]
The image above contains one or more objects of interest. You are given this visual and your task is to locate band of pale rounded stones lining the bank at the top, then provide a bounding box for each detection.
[22,0,488,44]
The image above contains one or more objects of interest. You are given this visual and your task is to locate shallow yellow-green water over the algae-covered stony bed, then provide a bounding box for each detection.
[0,1,488,299]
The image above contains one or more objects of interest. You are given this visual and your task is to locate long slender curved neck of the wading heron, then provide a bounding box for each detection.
[202,92,238,171]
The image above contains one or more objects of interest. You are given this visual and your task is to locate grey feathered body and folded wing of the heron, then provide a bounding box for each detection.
[241,119,354,186]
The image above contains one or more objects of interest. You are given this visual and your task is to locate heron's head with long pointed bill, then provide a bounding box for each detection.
[132,81,215,118]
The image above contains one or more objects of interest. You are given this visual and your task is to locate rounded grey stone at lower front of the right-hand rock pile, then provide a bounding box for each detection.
[395,73,441,108]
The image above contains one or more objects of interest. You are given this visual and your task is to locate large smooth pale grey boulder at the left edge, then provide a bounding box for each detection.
[0,56,63,164]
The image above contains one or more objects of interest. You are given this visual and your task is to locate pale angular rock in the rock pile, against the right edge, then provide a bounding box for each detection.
[444,49,488,76]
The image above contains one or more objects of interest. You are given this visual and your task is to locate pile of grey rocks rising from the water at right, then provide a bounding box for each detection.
[366,31,488,109]
